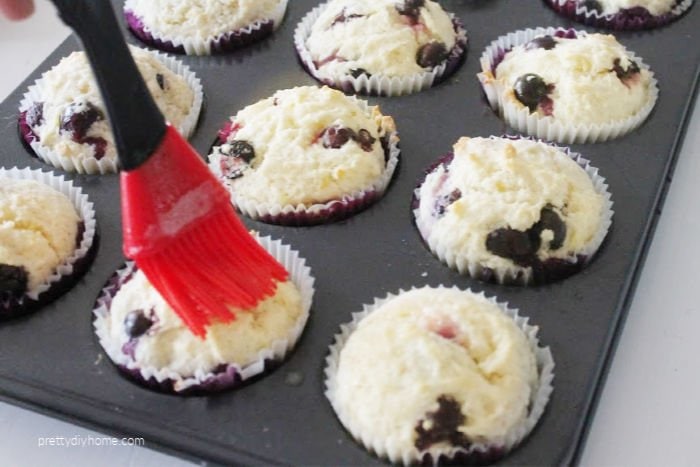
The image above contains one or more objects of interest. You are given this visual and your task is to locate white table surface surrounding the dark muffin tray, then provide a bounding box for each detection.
[0,1,700,466]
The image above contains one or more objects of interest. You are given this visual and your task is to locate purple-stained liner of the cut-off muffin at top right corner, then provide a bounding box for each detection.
[546,0,692,31]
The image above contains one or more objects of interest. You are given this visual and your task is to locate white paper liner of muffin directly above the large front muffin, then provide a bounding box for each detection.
[413,136,614,286]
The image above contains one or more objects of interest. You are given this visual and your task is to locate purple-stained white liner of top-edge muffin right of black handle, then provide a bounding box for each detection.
[124,0,287,55]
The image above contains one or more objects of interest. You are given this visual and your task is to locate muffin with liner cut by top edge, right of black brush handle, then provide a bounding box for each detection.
[124,0,287,55]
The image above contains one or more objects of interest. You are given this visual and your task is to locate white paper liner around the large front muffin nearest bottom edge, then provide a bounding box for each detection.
[325,286,554,466]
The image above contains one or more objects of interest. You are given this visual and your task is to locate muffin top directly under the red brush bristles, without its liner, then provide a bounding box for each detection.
[107,270,303,377]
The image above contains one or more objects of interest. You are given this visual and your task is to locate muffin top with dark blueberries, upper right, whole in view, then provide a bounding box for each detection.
[486,34,651,125]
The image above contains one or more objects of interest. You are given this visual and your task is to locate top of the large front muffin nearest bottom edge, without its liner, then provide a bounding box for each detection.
[329,287,538,459]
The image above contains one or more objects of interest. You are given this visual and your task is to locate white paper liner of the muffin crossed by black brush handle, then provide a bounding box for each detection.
[19,50,204,175]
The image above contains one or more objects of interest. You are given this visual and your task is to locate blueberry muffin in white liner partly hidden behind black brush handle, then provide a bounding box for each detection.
[19,47,202,173]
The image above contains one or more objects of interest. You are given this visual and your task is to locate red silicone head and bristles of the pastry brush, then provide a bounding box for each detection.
[122,127,288,336]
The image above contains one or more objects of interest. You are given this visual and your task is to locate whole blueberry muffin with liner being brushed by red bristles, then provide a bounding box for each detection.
[94,238,313,395]
